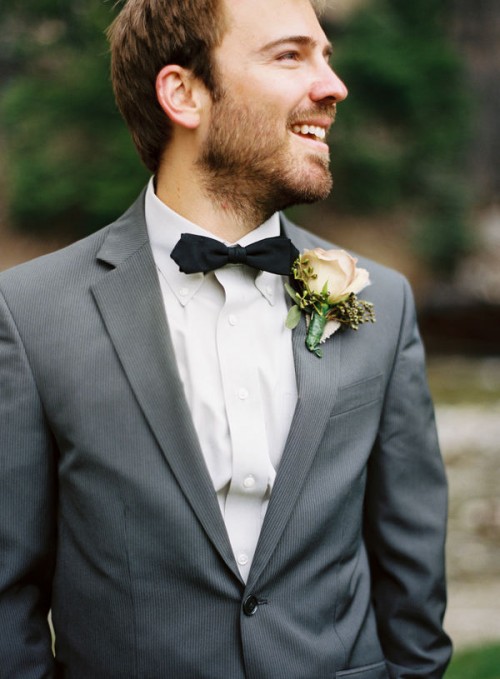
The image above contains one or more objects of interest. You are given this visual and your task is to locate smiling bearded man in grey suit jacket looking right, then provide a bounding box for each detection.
[0,0,450,679]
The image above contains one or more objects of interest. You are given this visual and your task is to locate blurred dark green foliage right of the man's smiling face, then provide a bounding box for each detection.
[333,0,469,273]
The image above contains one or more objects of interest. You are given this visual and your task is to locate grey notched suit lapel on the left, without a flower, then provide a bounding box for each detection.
[92,199,240,578]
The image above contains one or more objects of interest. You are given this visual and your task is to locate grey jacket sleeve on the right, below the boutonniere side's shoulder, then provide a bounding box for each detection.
[365,281,451,679]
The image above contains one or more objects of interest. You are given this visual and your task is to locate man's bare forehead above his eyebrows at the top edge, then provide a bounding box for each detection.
[222,0,328,51]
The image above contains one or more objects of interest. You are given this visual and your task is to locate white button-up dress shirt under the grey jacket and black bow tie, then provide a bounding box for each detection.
[145,180,297,580]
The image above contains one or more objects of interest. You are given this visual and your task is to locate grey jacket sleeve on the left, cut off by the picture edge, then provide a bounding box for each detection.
[0,294,56,679]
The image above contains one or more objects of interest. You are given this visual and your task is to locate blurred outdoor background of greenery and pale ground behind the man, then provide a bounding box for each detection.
[0,0,500,679]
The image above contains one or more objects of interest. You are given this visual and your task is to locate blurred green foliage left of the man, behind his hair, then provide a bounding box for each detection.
[0,0,147,237]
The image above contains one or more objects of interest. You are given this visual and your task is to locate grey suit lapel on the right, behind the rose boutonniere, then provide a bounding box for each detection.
[248,222,342,587]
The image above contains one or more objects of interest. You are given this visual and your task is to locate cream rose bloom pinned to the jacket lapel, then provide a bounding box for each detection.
[300,248,370,304]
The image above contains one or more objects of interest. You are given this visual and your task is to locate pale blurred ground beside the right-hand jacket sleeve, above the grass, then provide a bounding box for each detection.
[429,357,500,648]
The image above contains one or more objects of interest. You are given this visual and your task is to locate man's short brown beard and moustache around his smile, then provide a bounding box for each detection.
[197,93,335,223]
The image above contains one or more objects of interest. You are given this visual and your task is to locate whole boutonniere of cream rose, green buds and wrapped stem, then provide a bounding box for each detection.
[285,248,375,357]
